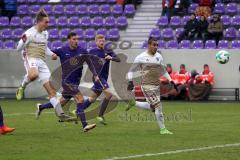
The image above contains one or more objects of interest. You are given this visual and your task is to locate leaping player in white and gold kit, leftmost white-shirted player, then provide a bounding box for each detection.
[16,10,70,120]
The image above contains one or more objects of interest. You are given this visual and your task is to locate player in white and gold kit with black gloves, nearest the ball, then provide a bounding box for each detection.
[127,38,174,134]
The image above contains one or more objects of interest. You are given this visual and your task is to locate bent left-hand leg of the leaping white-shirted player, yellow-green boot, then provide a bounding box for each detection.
[16,58,39,100]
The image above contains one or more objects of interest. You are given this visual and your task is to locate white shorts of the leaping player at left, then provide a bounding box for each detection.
[24,56,51,84]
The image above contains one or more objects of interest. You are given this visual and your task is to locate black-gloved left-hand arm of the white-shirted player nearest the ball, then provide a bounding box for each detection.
[127,57,140,91]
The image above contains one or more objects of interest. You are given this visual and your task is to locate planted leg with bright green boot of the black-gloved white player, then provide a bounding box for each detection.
[142,85,172,134]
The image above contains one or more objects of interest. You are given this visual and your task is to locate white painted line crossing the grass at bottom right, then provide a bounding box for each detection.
[104,143,240,160]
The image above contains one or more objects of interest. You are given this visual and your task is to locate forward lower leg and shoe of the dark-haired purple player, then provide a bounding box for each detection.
[74,92,96,132]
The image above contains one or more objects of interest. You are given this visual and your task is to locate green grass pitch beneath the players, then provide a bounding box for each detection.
[0,100,240,160]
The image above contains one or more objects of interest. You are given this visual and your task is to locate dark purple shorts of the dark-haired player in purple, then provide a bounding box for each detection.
[62,83,80,99]
